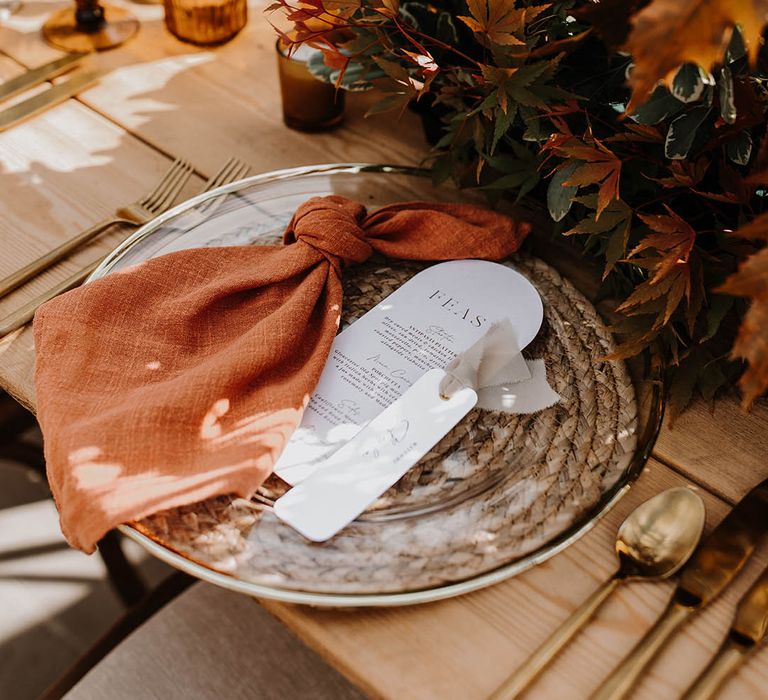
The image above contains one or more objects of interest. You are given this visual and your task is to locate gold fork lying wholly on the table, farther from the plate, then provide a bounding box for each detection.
[0,158,193,297]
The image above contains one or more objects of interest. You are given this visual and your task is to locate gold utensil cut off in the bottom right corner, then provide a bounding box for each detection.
[683,569,768,700]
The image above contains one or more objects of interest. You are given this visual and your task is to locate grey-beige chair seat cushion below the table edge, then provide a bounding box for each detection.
[66,583,364,700]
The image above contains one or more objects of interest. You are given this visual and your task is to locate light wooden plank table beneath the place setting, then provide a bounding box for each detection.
[0,0,768,700]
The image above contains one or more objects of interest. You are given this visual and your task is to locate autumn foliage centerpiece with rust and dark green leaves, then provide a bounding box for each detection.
[270,0,768,411]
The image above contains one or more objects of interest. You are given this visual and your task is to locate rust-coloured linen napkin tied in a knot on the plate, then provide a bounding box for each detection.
[34,196,529,552]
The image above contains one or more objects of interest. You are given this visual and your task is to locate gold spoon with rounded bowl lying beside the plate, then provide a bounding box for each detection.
[489,488,704,700]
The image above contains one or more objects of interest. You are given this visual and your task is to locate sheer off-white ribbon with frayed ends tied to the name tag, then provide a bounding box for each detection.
[440,319,560,414]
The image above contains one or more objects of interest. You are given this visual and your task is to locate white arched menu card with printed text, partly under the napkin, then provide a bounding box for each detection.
[275,260,543,485]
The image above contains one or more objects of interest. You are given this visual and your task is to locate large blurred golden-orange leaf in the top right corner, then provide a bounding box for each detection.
[624,0,765,113]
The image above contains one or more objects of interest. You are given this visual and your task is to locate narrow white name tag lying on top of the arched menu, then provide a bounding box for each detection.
[275,369,477,542]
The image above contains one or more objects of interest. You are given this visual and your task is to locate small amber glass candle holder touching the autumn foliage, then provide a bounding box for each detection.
[277,40,344,132]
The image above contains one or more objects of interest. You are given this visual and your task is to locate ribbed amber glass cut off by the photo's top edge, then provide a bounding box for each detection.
[164,0,248,46]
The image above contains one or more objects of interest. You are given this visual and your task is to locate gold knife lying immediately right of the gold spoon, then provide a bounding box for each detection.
[592,479,768,700]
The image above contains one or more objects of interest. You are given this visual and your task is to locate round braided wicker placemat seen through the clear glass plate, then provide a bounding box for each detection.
[133,249,638,593]
